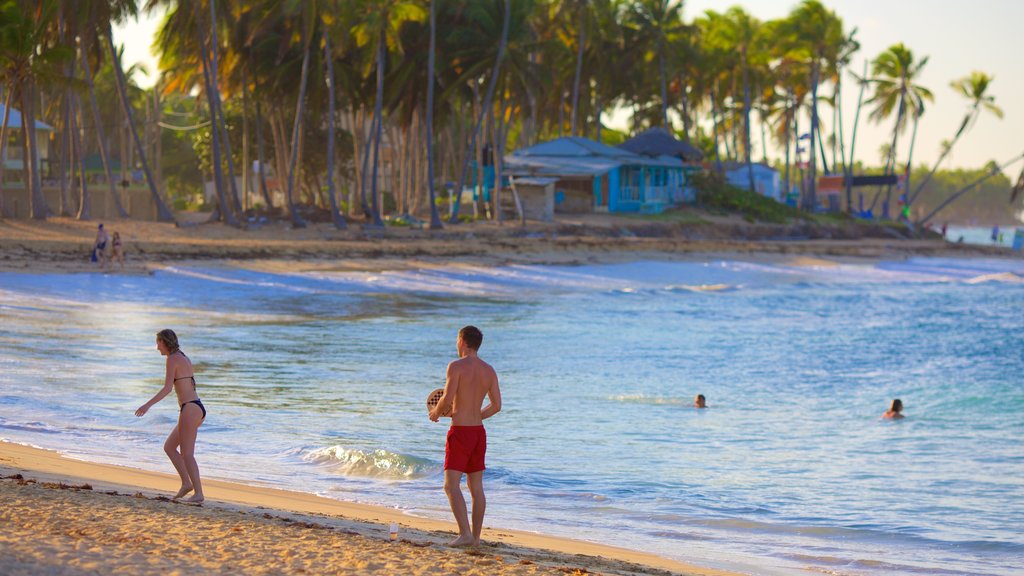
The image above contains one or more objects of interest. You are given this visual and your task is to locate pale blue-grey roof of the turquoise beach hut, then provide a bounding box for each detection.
[505,136,683,176]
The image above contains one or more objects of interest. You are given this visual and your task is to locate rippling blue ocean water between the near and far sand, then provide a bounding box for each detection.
[0,258,1024,575]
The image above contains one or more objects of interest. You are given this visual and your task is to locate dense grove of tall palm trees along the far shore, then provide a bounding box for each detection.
[0,0,1002,229]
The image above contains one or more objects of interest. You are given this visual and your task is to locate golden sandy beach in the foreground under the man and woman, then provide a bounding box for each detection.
[0,442,729,576]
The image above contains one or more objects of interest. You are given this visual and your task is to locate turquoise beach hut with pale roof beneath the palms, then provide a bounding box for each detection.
[505,136,685,213]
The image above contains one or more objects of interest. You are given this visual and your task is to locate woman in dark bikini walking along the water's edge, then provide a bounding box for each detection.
[135,328,206,503]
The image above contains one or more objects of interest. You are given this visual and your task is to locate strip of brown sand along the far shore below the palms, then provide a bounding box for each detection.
[0,218,1024,274]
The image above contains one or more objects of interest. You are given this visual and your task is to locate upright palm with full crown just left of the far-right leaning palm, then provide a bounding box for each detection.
[867,43,934,218]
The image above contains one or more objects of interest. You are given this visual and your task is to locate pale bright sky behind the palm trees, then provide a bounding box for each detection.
[115,0,1024,168]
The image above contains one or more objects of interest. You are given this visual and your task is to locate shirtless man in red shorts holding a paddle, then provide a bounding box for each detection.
[430,326,502,546]
